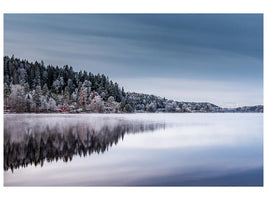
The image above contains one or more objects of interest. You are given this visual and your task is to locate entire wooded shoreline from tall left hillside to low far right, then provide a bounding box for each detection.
[4,56,263,113]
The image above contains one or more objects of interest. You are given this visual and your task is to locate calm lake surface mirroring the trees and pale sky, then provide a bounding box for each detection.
[4,113,263,186]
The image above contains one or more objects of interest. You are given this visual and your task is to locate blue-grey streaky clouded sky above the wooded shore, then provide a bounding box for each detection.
[4,14,263,107]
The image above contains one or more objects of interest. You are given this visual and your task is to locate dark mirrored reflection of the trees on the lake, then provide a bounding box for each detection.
[4,117,165,171]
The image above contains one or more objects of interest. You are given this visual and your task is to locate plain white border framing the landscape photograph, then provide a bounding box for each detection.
[0,0,267,200]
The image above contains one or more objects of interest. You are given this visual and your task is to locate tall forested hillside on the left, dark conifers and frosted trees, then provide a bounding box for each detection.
[4,56,129,112]
